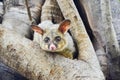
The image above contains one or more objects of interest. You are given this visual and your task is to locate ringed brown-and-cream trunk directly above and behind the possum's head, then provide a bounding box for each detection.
[41,0,63,23]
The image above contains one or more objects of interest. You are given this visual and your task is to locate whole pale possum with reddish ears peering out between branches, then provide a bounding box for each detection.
[32,19,75,59]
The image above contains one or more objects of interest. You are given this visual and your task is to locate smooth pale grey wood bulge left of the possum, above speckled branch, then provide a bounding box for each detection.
[2,8,32,38]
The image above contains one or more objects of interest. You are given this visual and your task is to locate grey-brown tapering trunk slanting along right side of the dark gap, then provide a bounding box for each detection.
[77,0,109,76]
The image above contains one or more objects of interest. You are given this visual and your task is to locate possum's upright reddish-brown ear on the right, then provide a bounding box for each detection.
[58,19,71,34]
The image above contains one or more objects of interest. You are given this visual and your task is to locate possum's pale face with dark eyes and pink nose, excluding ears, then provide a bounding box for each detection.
[41,30,67,52]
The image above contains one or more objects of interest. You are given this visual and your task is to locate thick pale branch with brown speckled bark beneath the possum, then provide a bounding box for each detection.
[0,28,104,80]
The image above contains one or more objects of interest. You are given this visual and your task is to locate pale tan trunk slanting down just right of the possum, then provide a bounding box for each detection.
[57,0,100,70]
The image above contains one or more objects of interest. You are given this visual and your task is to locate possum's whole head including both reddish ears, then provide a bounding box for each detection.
[32,20,70,52]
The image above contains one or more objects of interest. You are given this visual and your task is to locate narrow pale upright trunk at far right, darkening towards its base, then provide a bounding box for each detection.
[101,0,120,58]
